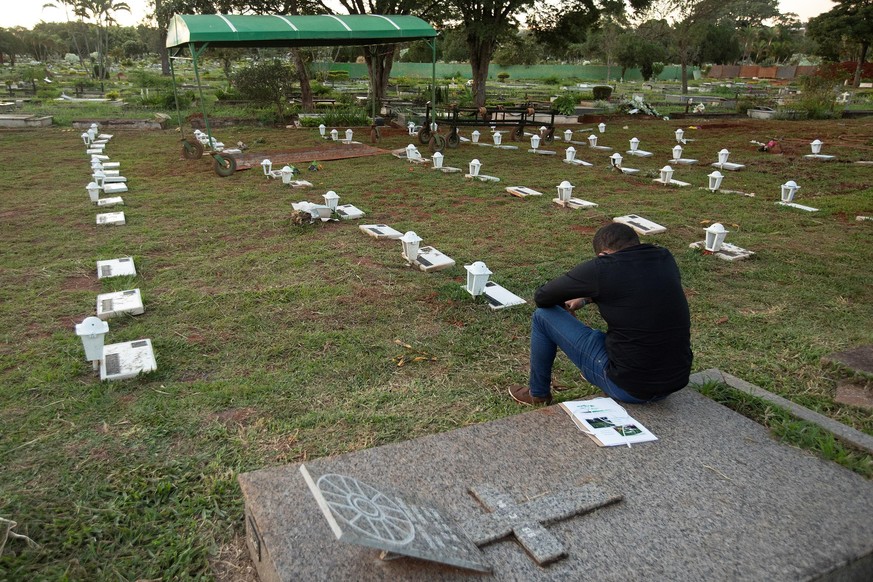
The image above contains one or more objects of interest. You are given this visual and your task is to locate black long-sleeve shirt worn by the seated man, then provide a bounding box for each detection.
[534,244,693,399]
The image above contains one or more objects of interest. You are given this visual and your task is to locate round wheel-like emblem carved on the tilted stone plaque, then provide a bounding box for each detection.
[317,473,415,545]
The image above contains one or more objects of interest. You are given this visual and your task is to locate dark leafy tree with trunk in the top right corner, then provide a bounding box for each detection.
[808,0,873,87]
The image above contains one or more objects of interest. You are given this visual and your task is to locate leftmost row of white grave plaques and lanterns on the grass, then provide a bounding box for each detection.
[75,128,157,380]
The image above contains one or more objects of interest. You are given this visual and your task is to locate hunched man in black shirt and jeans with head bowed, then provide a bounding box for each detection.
[509,223,692,405]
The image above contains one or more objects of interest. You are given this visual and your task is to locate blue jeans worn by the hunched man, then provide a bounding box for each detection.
[529,306,663,404]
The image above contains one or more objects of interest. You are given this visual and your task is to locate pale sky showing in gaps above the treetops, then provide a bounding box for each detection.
[0,0,834,28]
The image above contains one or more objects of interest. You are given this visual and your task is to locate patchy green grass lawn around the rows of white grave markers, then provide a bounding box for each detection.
[0,118,873,580]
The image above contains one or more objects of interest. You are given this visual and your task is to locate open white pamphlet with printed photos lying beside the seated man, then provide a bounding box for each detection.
[560,398,658,447]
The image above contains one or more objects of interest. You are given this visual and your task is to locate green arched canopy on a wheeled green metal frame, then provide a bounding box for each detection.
[167,14,437,176]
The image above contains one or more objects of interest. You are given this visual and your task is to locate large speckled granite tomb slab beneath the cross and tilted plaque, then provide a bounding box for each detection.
[239,389,873,582]
